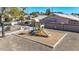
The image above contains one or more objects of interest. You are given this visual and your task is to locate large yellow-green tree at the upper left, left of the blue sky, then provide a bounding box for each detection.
[9,7,25,23]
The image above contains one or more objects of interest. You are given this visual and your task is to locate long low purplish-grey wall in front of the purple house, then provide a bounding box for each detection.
[45,23,79,32]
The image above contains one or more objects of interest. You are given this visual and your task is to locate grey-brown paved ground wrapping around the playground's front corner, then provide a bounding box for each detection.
[0,32,79,51]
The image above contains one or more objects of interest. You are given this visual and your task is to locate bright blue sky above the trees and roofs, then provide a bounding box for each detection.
[25,7,79,14]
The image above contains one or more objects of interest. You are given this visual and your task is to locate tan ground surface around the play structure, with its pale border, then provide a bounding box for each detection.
[14,29,67,48]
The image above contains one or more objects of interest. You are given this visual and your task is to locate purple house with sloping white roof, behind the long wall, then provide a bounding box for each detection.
[42,13,79,24]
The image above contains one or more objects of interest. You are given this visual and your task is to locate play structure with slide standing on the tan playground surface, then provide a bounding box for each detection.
[30,19,49,37]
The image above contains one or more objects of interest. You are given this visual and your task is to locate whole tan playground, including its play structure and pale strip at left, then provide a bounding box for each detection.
[0,19,67,48]
